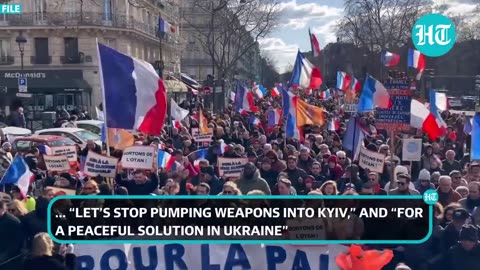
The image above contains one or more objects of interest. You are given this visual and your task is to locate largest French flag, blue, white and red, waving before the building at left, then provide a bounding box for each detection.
[98,43,167,135]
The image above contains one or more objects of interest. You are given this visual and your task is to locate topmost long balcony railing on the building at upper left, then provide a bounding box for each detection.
[0,12,170,40]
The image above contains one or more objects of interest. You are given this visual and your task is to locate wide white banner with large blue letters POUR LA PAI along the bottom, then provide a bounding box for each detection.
[75,244,348,270]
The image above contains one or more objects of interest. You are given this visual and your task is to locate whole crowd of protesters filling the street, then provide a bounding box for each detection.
[0,86,480,270]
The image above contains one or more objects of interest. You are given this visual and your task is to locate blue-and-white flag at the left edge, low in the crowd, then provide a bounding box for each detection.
[0,155,35,198]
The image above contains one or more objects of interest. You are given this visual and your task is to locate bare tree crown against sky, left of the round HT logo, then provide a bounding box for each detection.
[337,0,431,52]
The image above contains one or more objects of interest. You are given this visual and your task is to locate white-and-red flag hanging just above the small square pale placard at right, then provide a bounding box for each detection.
[410,99,442,141]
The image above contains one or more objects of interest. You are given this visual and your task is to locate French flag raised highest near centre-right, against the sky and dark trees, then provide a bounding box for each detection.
[290,51,323,89]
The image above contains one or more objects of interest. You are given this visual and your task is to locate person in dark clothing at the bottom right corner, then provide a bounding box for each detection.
[444,224,480,270]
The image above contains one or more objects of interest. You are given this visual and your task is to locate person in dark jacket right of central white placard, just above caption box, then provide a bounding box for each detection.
[236,162,271,195]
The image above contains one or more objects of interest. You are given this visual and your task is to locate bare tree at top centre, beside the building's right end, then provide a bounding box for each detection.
[183,0,279,78]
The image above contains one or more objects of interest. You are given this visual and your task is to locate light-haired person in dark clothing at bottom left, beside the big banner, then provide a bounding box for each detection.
[23,233,76,270]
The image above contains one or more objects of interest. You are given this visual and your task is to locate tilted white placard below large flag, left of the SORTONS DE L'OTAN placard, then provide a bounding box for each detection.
[83,151,118,177]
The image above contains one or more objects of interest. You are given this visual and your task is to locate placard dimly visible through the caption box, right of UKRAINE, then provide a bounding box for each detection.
[287,218,327,240]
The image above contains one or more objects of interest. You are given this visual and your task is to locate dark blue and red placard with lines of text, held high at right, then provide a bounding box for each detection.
[375,79,413,131]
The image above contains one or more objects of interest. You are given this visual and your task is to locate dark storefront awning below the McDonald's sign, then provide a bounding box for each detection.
[6,78,92,93]
